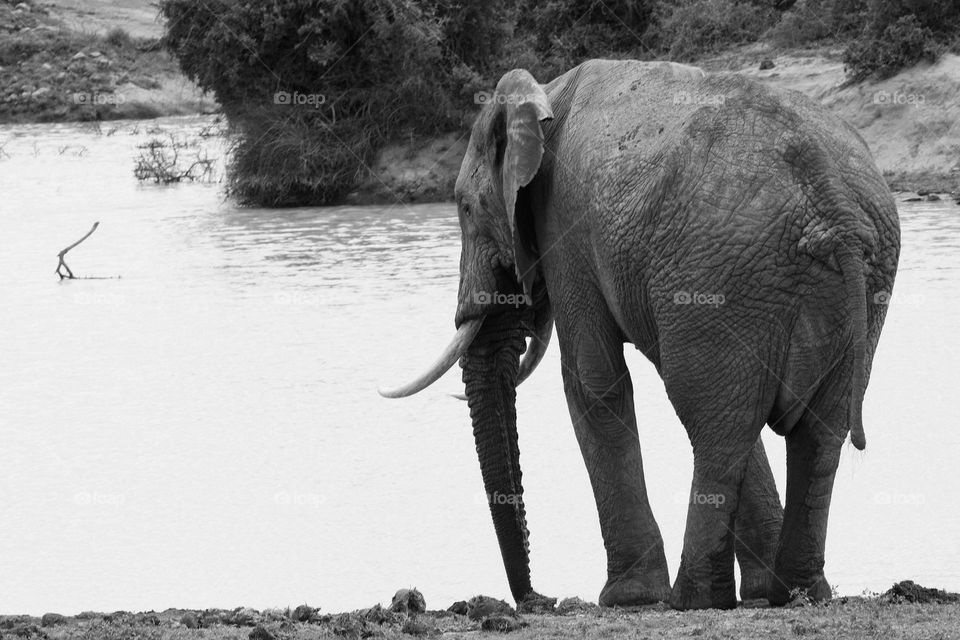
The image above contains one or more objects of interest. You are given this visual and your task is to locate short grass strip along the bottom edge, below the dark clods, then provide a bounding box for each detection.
[7,597,960,640]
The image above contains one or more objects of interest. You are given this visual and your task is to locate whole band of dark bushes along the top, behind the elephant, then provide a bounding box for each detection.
[154,0,960,206]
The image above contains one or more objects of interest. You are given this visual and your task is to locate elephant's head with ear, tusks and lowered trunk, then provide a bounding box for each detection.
[380,70,553,603]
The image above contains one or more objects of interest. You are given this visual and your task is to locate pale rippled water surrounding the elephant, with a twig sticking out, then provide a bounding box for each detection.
[0,120,960,614]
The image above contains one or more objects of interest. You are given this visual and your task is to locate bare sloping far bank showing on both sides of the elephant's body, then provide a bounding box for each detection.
[349,43,960,204]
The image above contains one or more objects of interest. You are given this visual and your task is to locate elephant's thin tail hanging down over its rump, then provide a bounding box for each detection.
[836,243,867,451]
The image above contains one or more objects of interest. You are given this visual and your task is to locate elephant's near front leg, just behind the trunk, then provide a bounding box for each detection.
[558,323,670,607]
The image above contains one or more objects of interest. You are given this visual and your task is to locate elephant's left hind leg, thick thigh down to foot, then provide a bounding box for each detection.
[661,330,776,609]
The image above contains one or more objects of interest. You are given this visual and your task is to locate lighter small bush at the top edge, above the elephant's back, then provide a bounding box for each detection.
[654,0,779,61]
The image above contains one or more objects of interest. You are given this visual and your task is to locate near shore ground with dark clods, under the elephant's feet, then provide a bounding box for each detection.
[11,582,960,640]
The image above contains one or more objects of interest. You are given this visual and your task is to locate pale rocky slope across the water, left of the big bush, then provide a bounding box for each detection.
[0,0,217,124]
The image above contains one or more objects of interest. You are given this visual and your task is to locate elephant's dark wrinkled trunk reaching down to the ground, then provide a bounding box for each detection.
[461,313,533,603]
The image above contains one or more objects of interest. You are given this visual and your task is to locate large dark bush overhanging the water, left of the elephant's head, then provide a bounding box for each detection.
[160,0,462,206]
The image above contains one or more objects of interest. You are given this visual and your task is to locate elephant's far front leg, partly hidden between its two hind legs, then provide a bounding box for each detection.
[734,438,783,602]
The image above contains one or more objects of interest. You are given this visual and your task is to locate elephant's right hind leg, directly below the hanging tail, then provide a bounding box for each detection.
[769,409,845,605]
